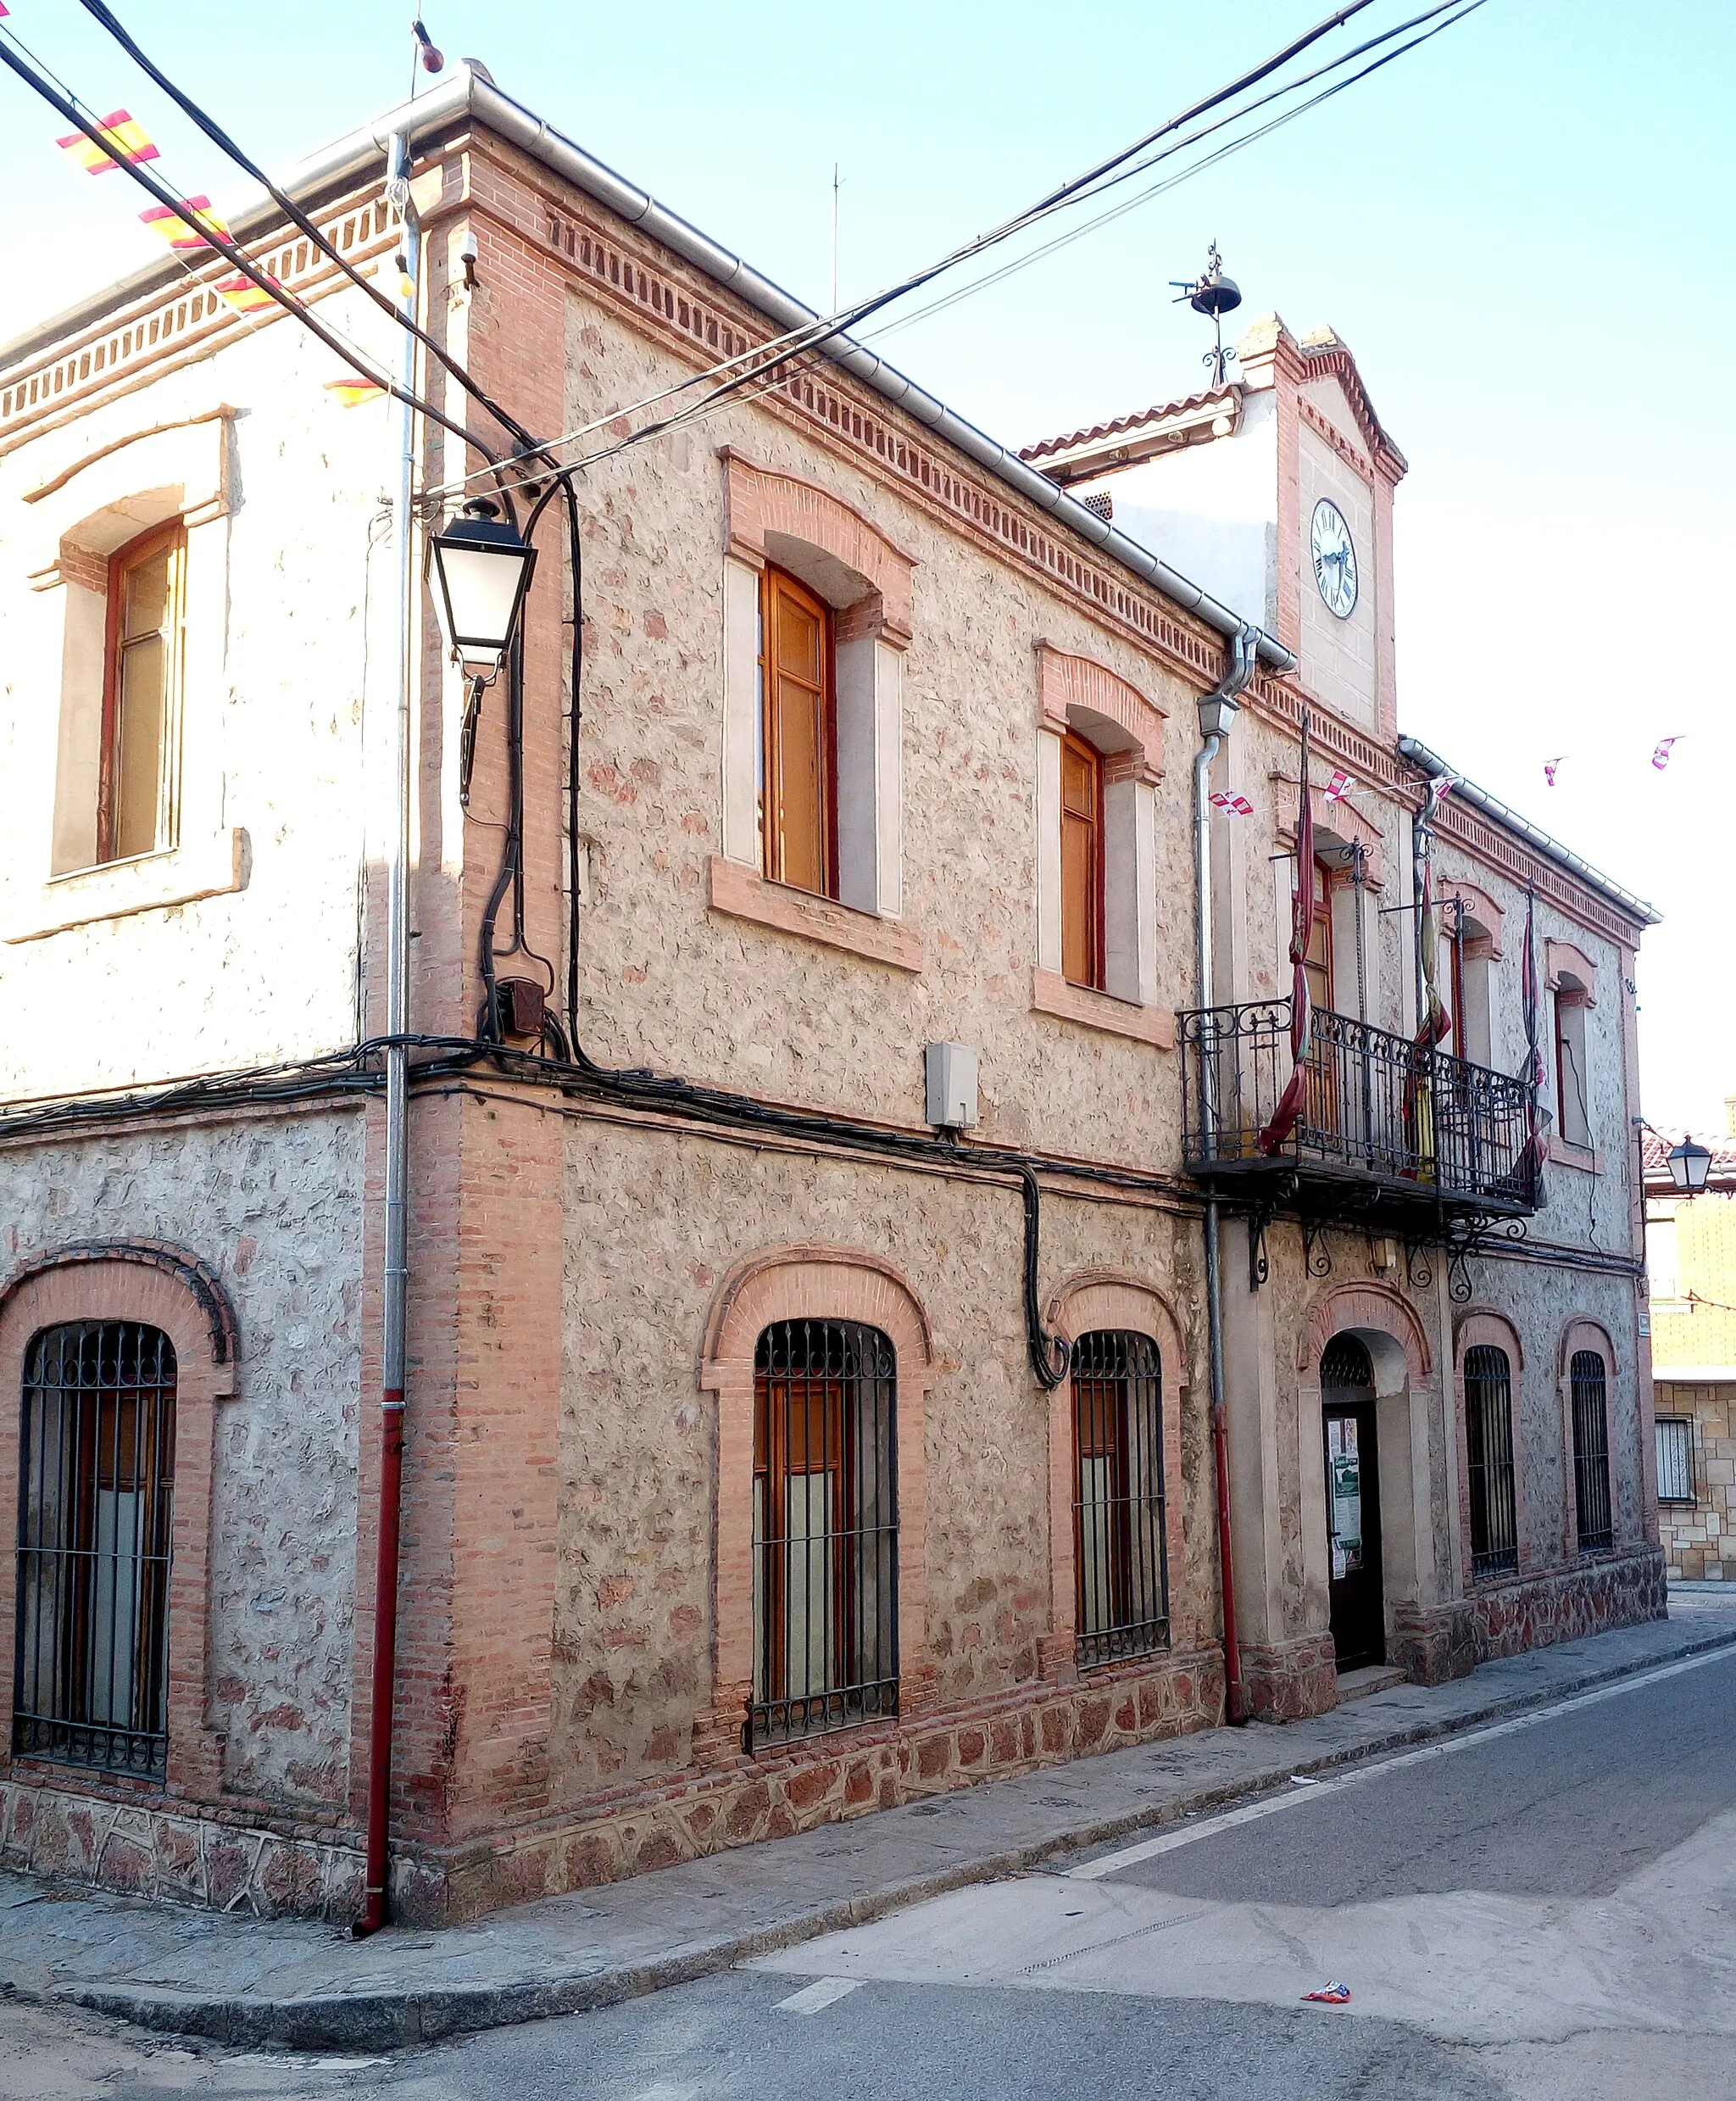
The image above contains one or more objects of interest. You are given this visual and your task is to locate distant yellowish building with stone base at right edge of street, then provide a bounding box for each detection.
[1641,1095,1736,1582]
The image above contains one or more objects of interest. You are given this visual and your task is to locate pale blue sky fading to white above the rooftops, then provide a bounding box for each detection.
[0,0,1736,1130]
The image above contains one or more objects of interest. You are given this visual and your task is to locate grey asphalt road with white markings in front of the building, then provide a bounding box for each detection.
[0,1652,1736,2101]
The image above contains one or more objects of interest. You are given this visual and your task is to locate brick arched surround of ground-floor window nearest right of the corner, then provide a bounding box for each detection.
[693,1246,935,1765]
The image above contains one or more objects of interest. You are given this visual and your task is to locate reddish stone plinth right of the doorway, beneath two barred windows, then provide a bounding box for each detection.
[1389,1546,1666,1685]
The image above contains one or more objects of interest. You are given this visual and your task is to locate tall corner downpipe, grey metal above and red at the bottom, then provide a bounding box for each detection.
[351,132,422,1939]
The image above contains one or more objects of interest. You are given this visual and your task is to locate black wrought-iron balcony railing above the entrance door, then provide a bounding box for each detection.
[1179,1000,1538,1212]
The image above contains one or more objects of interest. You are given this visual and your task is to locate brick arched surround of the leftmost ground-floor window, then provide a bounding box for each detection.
[0,1241,237,1798]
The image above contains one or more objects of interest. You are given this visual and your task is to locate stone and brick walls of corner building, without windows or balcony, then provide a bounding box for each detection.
[0,75,1662,1922]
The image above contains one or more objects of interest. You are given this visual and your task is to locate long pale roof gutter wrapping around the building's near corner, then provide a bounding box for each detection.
[0,63,1297,672]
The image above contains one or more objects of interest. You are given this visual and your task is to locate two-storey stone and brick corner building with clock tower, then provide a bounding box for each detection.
[0,67,1665,1922]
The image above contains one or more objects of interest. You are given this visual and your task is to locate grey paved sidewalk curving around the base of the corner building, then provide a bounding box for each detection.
[0,1586,1736,2051]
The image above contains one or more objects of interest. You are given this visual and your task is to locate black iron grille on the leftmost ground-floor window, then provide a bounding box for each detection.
[13,1322,175,1780]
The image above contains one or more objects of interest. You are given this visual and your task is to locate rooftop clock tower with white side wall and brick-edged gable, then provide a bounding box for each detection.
[1023,313,1404,744]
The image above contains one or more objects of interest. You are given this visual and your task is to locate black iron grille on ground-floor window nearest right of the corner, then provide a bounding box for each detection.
[748,1319,898,1748]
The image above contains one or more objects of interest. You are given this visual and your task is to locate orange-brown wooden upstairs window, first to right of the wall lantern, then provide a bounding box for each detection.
[759,567,838,897]
